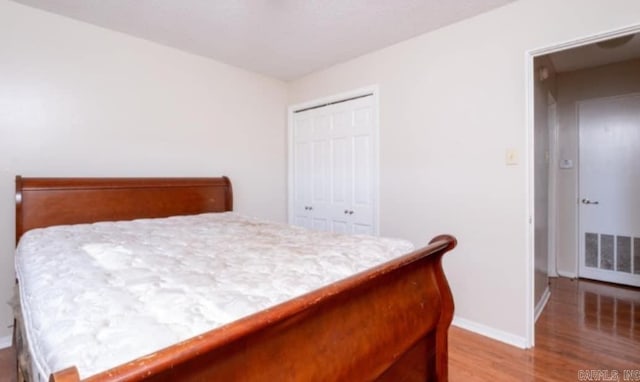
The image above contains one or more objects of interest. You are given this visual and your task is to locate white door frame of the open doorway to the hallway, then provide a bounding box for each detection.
[524,24,640,348]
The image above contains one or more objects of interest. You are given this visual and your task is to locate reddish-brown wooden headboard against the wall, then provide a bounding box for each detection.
[16,176,233,243]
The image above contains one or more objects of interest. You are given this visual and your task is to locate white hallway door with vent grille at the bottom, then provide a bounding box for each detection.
[578,95,640,286]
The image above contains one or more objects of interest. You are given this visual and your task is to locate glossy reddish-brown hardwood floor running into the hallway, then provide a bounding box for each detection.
[0,279,640,382]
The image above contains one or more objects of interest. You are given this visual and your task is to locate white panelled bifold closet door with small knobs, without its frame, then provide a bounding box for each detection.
[290,96,377,235]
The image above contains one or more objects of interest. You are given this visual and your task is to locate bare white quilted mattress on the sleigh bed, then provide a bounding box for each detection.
[16,213,413,380]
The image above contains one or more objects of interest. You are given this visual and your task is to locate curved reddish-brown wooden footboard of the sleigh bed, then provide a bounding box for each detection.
[50,235,456,382]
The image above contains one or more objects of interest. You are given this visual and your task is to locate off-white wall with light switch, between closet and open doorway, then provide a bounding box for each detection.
[289,0,640,346]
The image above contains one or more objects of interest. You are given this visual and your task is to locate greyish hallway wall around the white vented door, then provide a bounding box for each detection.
[556,59,640,276]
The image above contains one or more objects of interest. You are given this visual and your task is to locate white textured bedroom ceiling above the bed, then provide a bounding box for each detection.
[14,0,514,80]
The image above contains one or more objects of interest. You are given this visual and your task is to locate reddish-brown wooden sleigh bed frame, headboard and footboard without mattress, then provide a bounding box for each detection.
[16,177,456,382]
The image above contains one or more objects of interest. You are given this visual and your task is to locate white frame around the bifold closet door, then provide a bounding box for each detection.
[287,84,380,235]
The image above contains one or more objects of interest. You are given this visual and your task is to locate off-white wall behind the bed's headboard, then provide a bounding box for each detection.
[0,0,287,342]
